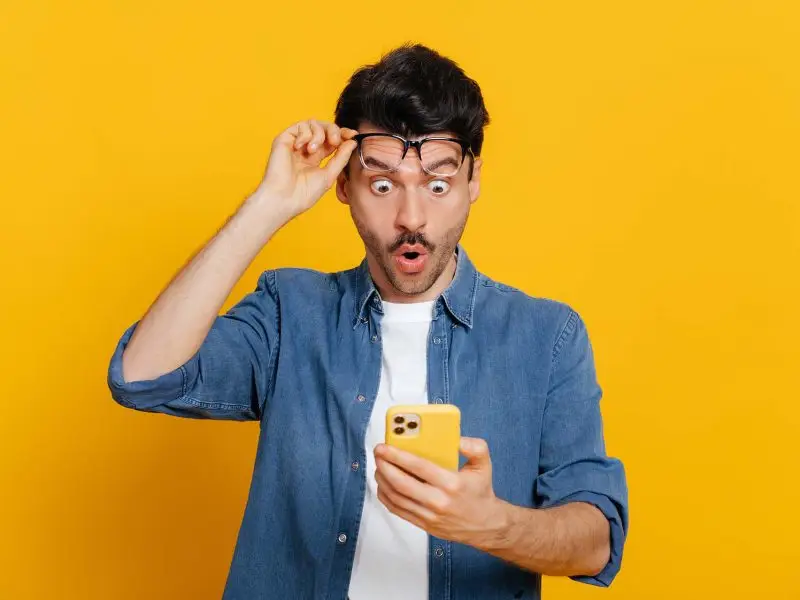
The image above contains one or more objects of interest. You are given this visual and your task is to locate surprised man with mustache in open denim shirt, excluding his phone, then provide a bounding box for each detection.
[109,46,627,600]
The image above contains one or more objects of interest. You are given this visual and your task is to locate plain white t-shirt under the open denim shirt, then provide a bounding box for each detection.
[349,301,435,600]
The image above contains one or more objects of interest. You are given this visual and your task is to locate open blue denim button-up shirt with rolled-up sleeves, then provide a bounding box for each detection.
[108,247,628,600]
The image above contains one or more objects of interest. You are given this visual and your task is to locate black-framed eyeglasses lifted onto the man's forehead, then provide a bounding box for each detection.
[353,133,475,177]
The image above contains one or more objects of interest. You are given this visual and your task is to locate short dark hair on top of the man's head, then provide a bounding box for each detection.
[335,44,489,177]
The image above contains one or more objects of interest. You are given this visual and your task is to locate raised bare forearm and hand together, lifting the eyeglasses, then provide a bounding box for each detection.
[122,121,357,381]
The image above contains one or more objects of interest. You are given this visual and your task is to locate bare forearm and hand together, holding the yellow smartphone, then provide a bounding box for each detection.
[375,438,610,575]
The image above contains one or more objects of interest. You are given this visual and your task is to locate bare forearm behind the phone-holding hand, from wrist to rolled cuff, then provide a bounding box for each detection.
[481,501,610,576]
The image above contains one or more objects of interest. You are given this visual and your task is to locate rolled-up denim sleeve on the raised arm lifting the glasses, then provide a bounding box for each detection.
[108,271,280,421]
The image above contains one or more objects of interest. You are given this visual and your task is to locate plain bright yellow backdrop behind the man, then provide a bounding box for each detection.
[0,0,800,600]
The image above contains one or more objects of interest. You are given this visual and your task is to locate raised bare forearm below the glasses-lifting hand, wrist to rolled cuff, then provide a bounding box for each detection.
[122,192,289,381]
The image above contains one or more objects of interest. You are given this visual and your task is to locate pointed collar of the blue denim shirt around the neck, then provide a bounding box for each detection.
[353,244,478,328]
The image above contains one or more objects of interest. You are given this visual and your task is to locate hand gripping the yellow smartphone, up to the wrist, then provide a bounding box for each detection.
[375,437,507,547]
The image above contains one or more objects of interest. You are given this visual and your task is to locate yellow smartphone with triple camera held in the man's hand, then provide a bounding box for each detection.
[386,404,461,471]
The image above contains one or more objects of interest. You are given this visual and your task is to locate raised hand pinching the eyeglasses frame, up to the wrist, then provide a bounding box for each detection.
[258,120,358,219]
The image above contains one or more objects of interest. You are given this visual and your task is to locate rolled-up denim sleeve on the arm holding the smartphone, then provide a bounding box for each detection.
[534,310,628,586]
